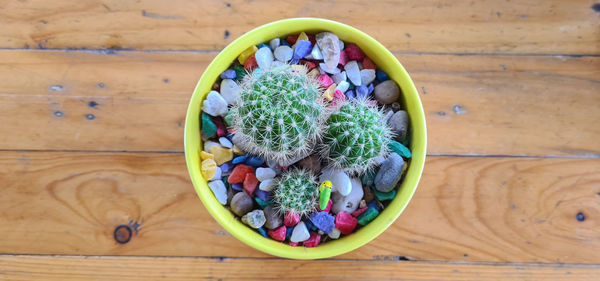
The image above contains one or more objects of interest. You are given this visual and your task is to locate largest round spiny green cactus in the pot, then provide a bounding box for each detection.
[230,65,326,162]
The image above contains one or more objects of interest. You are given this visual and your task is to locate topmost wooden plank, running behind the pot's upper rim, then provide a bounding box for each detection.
[0,0,600,54]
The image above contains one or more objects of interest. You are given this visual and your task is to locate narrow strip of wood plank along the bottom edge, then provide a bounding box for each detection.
[0,256,600,281]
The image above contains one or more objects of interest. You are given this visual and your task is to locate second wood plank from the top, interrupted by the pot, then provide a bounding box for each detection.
[0,50,600,157]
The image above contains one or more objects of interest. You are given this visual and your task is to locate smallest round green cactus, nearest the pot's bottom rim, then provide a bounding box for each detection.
[273,168,319,217]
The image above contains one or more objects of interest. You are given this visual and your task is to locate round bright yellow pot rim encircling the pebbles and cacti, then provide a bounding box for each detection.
[184,18,427,259]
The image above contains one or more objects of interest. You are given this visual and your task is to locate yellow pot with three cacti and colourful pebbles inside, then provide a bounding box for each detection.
[186,19,425,258]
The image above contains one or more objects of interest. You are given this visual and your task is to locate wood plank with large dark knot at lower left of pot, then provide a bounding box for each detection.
[0,152,600,264]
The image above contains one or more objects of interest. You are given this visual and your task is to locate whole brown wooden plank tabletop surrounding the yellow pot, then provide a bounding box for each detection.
[0,0,600,280]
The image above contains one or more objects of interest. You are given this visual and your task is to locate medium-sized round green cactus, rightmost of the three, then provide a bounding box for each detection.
[321,99,392,174]
